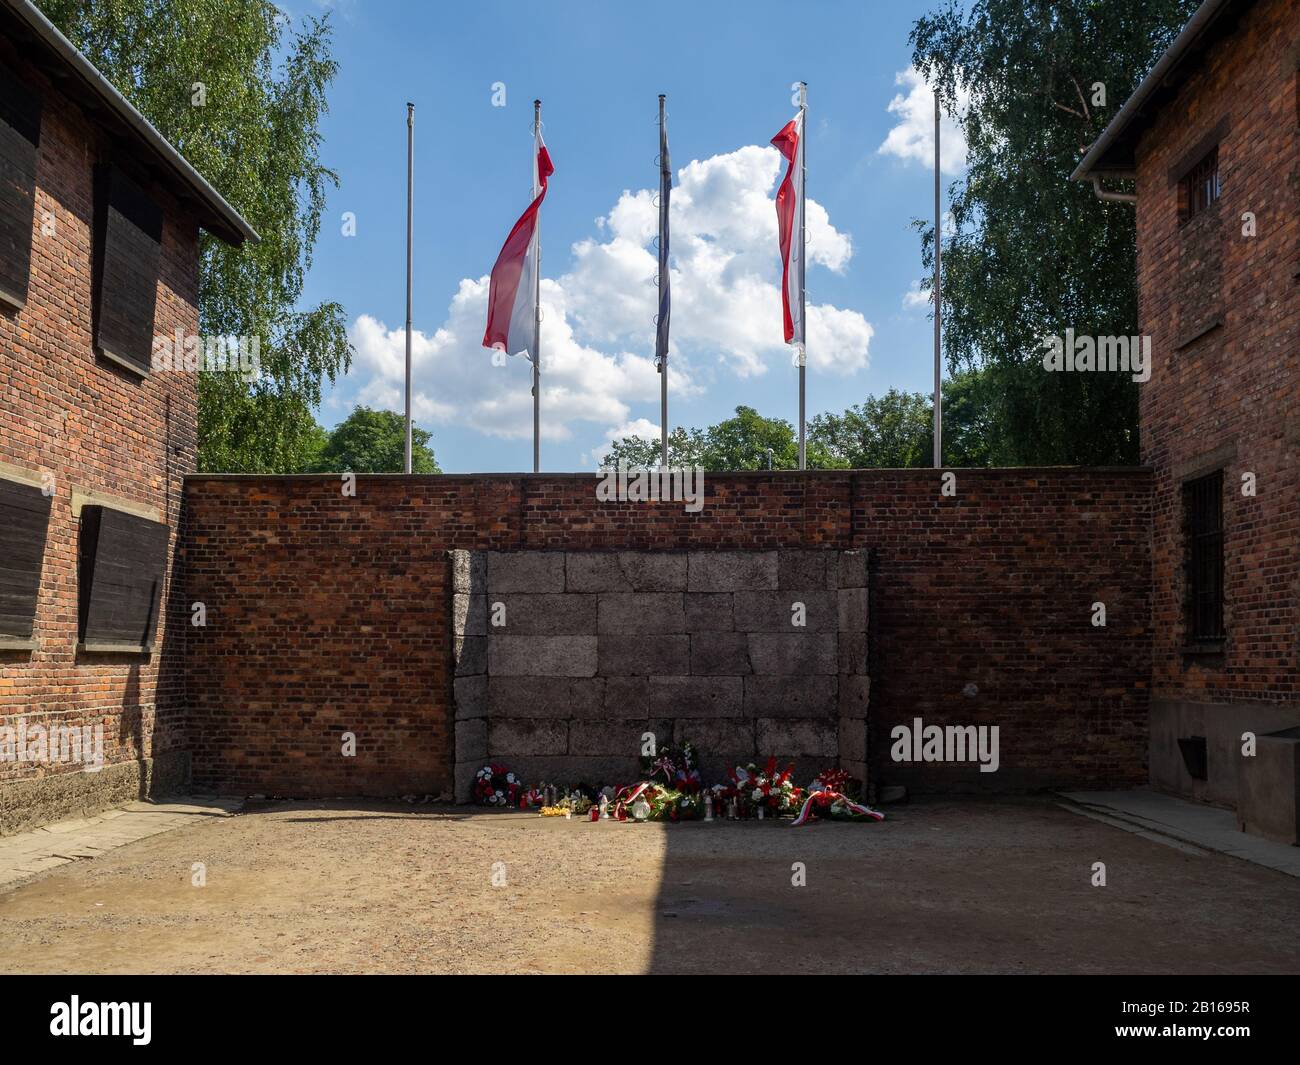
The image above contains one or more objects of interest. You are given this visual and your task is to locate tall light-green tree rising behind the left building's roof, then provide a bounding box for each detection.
[38,0,351,472]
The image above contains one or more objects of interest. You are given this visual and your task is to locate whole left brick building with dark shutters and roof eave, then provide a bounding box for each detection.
[0,0,256,831]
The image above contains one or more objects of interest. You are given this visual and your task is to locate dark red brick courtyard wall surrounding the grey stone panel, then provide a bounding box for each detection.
[182,469,1151,795]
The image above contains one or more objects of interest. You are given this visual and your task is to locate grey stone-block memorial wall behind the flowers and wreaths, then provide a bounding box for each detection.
[452,550,870,801]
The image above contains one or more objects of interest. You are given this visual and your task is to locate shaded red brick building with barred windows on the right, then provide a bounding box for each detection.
[1075,0,1300,804]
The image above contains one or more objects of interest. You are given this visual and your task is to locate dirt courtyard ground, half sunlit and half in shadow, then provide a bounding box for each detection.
[0,798,1300,973]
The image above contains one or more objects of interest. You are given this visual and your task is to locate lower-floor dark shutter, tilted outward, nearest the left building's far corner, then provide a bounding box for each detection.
[78,506,168,650]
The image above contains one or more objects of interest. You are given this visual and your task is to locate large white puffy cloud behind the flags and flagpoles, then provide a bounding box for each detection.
[351,139,874,447]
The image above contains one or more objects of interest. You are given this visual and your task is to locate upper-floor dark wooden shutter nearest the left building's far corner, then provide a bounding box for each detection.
[95,164,163,373]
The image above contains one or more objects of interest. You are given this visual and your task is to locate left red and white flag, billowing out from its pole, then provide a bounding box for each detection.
[484,126,555,360]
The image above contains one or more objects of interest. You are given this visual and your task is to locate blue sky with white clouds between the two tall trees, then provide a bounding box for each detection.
[290,0,963,472]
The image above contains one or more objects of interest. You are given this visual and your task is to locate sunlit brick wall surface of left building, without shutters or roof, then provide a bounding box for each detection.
[0,40,199,831]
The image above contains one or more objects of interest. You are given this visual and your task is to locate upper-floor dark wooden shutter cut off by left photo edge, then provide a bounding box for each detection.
[0,64,42,309]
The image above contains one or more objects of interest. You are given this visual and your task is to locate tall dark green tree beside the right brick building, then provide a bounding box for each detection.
[911,0,1199,464]
